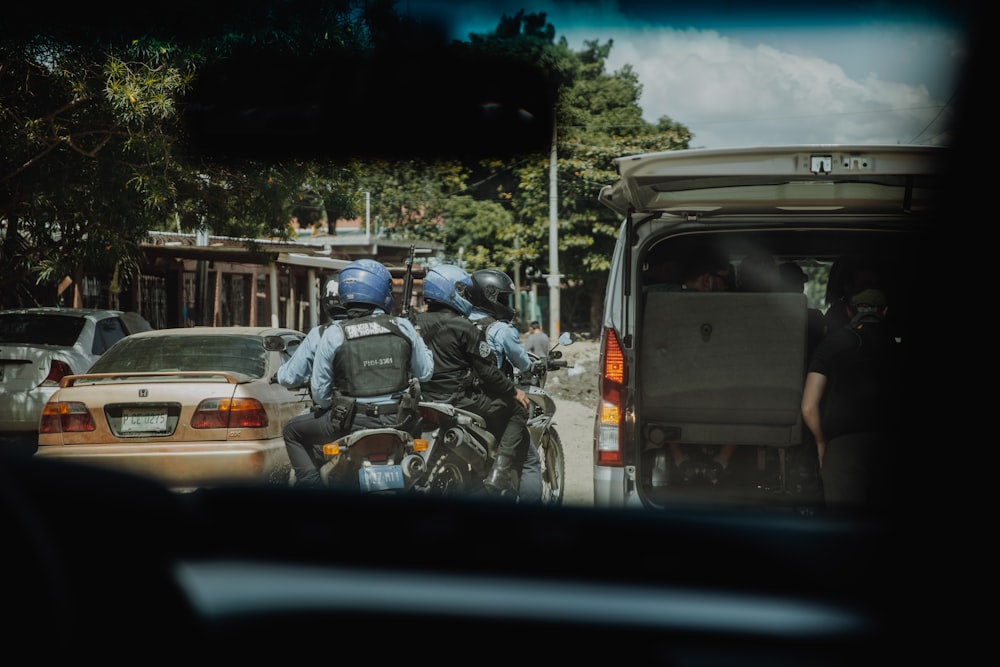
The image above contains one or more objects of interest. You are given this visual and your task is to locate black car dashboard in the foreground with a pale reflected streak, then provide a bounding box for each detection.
[0,448,898,665]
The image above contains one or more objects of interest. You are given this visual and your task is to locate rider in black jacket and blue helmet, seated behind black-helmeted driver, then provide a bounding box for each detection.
[417,264,530,498]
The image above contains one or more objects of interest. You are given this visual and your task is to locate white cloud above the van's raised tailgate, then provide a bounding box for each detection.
[567,28,944,148]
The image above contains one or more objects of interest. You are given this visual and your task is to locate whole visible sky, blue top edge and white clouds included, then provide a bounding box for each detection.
[399,0,967,148]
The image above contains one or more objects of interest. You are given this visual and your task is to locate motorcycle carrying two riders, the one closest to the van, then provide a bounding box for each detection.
[406,332,576,505]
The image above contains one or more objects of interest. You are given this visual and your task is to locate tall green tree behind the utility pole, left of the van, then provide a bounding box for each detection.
[471,12,691,334]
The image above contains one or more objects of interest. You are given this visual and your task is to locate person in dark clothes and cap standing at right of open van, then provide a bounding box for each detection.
[802,289,902,510]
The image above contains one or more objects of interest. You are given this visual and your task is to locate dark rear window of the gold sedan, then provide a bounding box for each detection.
[89,335,267,378]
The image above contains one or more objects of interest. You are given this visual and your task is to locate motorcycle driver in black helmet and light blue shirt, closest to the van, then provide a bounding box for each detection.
[469,269,544,502]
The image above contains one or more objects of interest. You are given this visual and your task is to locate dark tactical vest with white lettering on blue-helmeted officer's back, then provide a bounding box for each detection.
[333,315,412,397]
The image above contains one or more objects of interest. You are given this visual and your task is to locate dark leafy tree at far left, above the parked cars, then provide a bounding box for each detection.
[0,0,394,306]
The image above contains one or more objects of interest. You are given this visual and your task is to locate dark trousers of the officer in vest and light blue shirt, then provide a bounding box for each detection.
[282,408,396,487]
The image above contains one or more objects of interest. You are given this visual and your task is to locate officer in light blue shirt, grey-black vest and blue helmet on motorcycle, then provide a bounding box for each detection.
[283,259,434,487]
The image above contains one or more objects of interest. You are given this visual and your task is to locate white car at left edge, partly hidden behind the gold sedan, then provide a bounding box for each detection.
[0,308,152,454]
